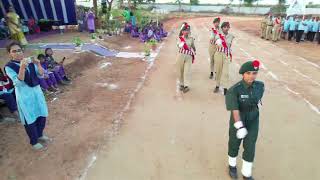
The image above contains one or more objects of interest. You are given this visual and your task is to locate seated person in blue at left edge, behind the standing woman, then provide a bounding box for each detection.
[0,69,19,120]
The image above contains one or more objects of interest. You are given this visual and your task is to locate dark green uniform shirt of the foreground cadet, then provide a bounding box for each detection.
[225,80,264,112]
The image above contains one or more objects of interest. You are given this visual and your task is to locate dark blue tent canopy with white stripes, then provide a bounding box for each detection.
[0,0,77,24]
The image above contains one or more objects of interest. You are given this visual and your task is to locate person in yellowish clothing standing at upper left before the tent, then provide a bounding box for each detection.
[6,6,28,46]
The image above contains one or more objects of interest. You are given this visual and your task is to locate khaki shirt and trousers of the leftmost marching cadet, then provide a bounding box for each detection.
[176,37,195,86]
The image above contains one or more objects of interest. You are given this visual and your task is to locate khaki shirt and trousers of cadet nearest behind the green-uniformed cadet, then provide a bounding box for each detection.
[214,34,234,88]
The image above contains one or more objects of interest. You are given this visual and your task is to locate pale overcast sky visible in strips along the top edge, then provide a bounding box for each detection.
[76,0,320,6]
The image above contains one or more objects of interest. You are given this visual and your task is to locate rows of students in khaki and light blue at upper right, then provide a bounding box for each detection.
[261,14,320,44]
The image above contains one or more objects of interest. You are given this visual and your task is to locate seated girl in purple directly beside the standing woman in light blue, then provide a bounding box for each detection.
[38,54,59,93]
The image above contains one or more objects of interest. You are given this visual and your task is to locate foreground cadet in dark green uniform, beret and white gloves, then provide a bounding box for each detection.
[226,60,264,180]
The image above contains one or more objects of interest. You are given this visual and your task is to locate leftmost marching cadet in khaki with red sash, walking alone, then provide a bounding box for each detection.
[177,23,196,93]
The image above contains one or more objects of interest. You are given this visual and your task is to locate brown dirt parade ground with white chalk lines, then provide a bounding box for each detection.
[0,16,320,180]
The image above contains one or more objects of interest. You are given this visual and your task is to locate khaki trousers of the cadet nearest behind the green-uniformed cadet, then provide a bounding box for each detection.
[214,51,231,88]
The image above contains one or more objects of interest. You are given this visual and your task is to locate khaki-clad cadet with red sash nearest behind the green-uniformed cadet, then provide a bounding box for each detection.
[213,22,234,95]
